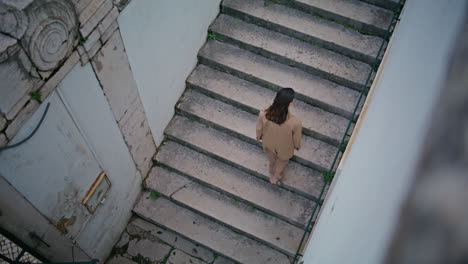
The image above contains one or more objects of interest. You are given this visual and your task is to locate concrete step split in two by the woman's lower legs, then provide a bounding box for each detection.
[165,116,323,199]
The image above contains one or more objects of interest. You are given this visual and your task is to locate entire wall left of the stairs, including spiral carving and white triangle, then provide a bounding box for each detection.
[0,0,220,262]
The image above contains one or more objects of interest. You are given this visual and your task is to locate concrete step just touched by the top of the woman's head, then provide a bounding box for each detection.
[198,41,359,120]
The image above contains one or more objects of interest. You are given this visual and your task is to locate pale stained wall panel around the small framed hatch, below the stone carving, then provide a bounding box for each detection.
[0,64,141,261]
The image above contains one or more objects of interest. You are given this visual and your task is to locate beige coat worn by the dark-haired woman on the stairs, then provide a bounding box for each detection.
[257,110,302,160]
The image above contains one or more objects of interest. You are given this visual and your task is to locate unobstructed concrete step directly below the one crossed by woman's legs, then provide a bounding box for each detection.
[156,141,315,228]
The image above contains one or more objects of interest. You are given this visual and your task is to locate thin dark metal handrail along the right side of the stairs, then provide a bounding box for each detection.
[291,0,403,264]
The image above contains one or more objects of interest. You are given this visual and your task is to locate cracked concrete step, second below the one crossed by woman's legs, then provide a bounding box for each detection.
[146,167,304,256]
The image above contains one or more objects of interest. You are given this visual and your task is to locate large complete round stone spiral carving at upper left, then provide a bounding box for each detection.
[22,0,78,71]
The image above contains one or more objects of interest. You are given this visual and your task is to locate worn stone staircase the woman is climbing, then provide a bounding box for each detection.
[134,0,397,264]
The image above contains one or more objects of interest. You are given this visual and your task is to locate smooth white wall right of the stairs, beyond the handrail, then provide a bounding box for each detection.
[304,0,468,264]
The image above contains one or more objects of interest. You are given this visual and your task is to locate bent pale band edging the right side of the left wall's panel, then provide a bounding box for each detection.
[58,64,141,259]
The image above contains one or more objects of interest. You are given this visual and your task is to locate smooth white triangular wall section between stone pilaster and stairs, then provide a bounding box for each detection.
[118,0,220,145]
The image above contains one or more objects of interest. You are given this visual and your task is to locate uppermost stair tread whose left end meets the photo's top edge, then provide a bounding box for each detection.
[223,0,382,58]
